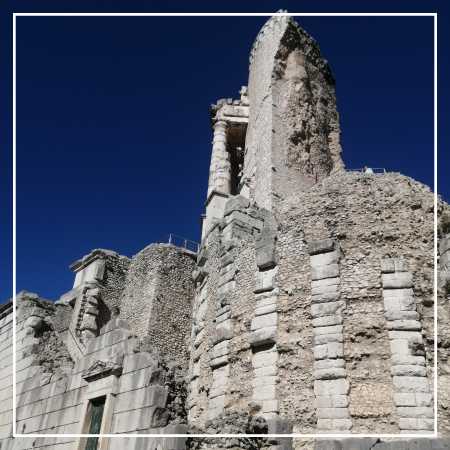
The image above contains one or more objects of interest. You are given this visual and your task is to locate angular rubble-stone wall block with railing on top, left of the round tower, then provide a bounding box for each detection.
[120,244,196,368]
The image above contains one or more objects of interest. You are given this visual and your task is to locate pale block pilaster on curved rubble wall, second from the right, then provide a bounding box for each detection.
[308,239,353,433]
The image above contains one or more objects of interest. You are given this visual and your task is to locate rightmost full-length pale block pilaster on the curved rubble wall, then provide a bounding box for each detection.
[381,258,434,434]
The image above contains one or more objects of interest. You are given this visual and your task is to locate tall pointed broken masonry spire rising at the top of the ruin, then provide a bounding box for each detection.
[243,16,344,209]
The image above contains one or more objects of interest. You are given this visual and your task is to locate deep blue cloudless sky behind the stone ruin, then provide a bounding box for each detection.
[0,0,450,303]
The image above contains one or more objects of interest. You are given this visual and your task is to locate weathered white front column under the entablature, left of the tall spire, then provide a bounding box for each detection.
[207,120,231,197]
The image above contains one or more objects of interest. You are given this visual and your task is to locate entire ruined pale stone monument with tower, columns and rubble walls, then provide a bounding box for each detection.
[0,11,450,450]
